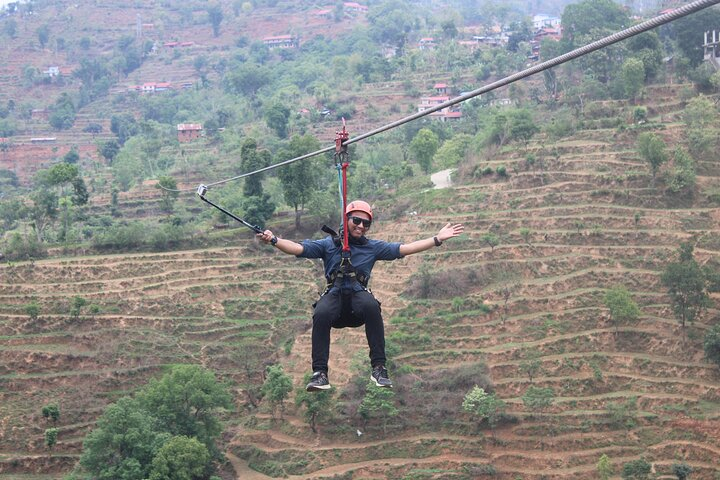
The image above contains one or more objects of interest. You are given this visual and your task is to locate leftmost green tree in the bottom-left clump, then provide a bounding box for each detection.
[80,397,172,480]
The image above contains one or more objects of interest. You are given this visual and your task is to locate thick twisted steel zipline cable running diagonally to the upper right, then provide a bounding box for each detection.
[172,0,720,192]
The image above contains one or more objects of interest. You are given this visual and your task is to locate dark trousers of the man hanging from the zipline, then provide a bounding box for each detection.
[312,290,385,373]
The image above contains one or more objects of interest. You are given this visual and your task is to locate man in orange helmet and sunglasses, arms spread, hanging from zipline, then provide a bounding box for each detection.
[258,200,464,392]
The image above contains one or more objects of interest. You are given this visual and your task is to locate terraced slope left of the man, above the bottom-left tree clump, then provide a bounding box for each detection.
[0,238,324,479]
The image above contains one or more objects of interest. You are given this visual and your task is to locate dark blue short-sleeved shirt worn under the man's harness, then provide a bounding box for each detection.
[298,237,403,290]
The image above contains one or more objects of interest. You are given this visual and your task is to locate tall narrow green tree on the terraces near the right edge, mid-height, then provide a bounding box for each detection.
[661,243,711,328]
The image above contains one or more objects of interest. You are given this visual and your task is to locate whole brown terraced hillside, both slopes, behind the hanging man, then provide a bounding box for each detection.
[0,63,720,480]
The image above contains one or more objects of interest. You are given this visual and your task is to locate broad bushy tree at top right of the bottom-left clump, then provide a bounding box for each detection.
[138,365,232,454]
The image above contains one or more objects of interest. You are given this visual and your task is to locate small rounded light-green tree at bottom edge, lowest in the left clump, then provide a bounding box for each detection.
[148,435,210,480]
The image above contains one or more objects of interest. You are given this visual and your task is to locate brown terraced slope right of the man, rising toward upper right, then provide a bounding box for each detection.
[224,84,720,480]
